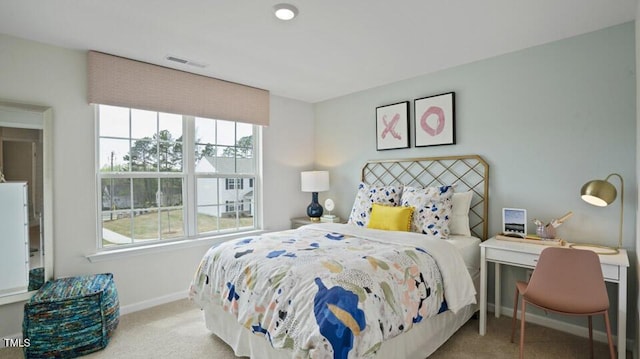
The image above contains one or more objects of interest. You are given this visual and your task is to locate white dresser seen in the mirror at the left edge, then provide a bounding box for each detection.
[0,182,29,295]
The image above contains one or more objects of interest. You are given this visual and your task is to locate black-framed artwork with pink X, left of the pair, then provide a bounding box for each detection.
[376,101,409,151]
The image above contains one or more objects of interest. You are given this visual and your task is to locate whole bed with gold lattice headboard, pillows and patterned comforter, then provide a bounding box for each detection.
[189,155,489,358]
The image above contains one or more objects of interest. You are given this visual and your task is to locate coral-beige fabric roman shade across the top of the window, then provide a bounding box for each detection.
[88,51,269,126]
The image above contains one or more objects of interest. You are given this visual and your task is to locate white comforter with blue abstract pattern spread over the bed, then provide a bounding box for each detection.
[190,223,475,358]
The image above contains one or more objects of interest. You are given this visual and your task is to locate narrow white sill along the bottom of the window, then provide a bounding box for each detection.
[85,230,266,263]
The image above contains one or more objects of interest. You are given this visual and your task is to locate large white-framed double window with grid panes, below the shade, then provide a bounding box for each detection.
[96,105,259,248]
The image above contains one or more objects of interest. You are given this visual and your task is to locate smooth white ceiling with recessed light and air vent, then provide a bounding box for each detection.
[0,0,637,103]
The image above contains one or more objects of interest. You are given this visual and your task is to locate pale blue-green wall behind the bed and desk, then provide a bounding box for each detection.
[315,23,637,338]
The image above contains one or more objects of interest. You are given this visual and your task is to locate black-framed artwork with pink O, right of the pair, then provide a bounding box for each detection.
[413,92,456,147]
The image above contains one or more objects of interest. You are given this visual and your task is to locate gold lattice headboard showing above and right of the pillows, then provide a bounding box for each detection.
[362,155,489,241]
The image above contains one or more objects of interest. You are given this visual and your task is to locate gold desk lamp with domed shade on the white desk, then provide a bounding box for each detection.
[570,173,624,254]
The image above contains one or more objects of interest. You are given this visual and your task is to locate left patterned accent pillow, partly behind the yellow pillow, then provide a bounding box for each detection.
[347,182,402,227]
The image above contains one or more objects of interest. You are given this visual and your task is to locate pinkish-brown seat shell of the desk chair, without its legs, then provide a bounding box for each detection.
[523,247,609,314]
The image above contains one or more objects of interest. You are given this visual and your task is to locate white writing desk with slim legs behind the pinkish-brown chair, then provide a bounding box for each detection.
[479,238,629,358]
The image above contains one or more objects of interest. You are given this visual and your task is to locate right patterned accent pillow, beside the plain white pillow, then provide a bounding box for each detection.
[400,186,453,239]
